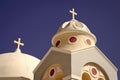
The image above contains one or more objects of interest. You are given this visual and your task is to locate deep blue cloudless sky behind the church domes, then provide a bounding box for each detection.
[0,0,120,77]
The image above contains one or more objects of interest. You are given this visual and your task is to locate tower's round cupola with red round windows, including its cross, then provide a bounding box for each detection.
[52,9,96,51]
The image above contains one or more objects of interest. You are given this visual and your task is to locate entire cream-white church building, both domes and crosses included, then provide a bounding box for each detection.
[0,9,118,80]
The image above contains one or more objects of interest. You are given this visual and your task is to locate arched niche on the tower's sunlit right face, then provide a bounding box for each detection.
[81,62,109,80]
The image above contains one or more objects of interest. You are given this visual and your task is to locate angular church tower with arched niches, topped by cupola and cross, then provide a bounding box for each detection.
[34,9,118,80]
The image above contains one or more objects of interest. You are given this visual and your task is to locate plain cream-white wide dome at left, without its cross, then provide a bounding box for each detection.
[0,51,40,80]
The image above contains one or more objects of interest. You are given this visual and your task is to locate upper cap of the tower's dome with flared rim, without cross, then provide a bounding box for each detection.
[52,19,96,45]
